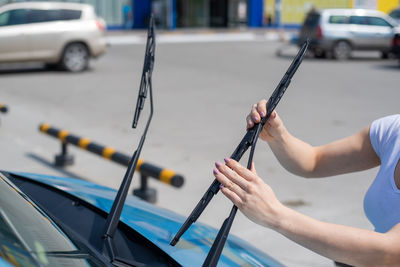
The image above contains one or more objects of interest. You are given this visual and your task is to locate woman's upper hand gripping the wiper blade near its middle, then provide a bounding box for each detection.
[246,99,286,142]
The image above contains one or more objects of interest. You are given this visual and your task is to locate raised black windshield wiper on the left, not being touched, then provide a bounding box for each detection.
[103,16,156,266]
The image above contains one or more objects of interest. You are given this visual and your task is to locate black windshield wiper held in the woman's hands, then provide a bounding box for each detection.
[170,40,309,266]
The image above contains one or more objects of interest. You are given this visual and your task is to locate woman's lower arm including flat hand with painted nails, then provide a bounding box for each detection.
[213,159,400,267]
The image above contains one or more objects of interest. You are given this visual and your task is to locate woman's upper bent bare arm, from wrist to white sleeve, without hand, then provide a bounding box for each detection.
[266,125,380,177]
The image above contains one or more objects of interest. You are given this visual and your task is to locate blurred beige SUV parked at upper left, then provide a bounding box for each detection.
[0,2,107,72]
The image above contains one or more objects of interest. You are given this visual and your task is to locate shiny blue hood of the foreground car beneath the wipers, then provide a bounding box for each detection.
[15,173,283,267]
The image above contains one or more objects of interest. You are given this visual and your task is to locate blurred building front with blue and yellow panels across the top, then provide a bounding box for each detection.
[0,0,400,29]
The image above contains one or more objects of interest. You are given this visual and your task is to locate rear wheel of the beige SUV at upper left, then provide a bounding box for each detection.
[61,43,89,72]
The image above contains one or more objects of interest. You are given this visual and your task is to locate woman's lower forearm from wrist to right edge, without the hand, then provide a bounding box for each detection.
[270,207,400,266]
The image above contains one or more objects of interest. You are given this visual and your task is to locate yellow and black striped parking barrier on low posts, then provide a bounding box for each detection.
[39,123,184,187]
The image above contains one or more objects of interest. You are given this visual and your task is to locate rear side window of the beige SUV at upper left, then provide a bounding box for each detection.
[27,9,82,23]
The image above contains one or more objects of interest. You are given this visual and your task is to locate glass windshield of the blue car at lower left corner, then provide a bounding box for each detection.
[0,176,96,266]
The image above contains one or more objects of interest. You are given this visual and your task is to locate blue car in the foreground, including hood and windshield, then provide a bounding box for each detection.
[0,171,283,267]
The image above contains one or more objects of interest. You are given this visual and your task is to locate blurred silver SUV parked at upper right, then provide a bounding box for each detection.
[298,9,399,60]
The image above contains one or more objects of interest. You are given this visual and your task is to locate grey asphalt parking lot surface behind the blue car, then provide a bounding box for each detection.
[0,30,400,266]
